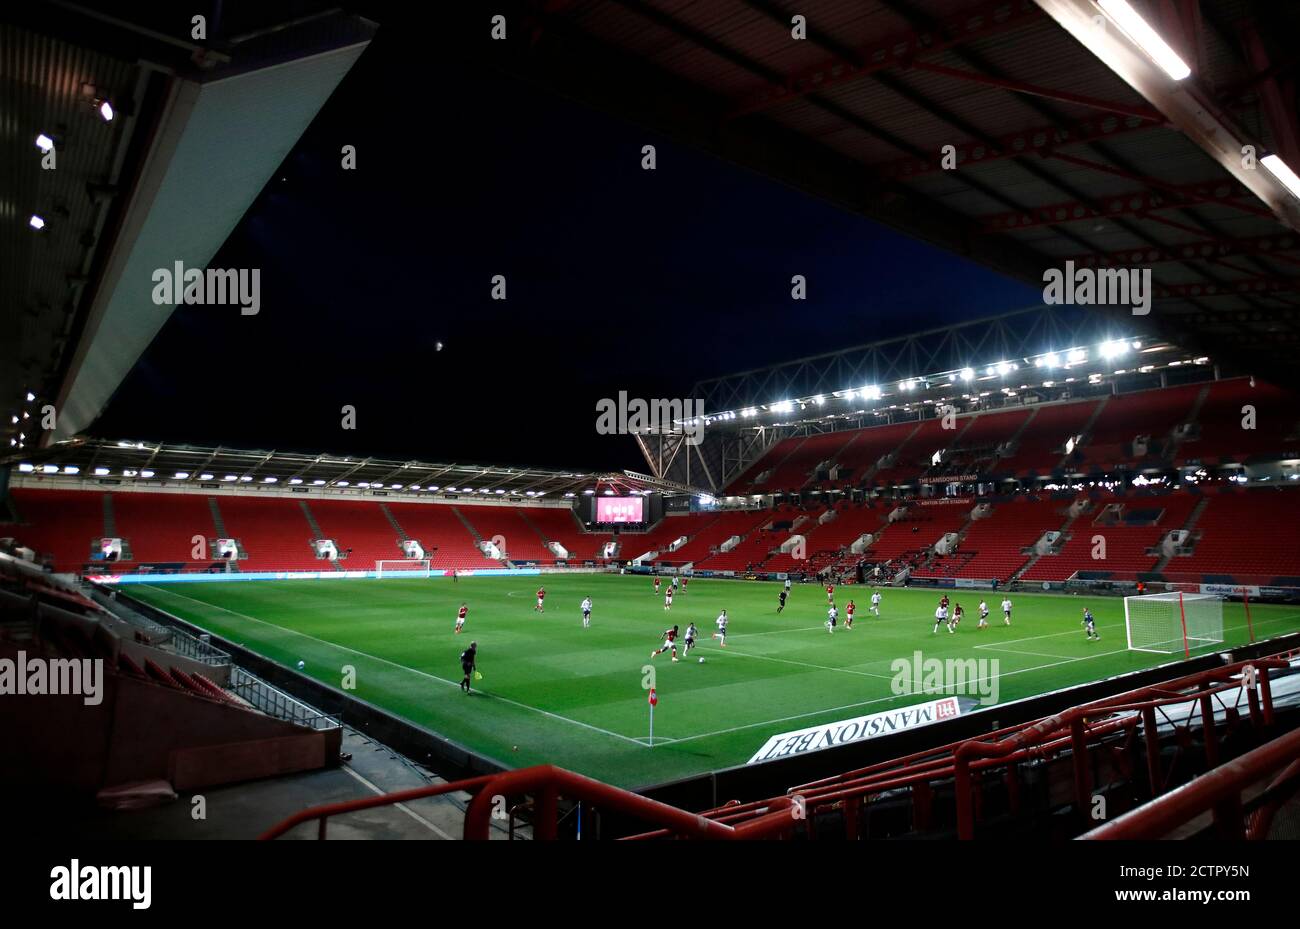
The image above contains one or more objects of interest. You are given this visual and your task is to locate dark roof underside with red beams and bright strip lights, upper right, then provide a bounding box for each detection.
[488,0,1300,379]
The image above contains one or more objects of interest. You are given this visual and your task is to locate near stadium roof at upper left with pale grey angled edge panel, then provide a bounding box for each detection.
[0,0,376,447]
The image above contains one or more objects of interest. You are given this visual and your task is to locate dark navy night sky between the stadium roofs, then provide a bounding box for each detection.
[88,3,1039,469]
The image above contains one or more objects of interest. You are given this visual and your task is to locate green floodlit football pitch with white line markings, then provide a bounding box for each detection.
[127,574,1300,787]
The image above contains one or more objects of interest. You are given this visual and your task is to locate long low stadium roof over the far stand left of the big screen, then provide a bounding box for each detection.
[5,438,706,499]
